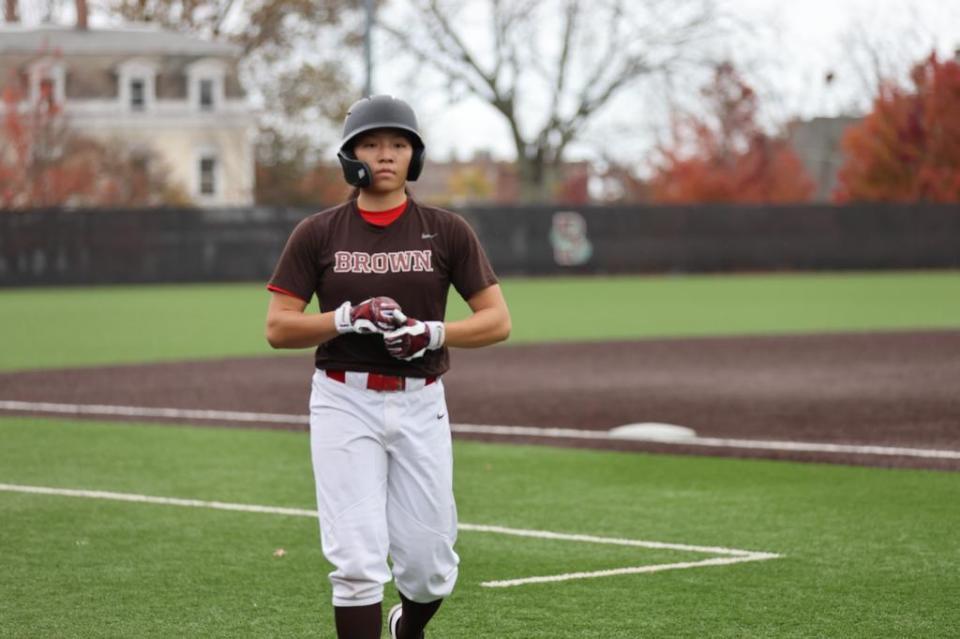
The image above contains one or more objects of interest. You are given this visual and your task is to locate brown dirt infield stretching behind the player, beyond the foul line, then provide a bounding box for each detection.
[0,331,960,470]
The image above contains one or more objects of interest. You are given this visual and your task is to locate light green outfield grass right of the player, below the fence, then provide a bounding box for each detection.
[484,272,960,342]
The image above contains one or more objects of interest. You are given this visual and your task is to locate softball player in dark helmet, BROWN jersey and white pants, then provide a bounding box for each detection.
[266,95,510,639]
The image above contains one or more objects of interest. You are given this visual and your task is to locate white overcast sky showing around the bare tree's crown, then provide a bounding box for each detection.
[374,0,960,161]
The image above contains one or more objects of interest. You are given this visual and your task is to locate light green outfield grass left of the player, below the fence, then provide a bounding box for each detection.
[0,284,270,370]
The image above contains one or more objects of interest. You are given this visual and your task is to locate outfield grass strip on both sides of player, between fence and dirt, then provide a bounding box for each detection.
[0,272,960,371]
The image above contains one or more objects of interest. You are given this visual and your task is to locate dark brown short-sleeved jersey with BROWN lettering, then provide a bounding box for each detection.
[269,199,497,377]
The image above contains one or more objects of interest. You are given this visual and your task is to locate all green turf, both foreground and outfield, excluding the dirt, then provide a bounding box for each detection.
[0,273,960,639]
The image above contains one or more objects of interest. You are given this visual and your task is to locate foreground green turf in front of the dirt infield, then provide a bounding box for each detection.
[0,417,960,639]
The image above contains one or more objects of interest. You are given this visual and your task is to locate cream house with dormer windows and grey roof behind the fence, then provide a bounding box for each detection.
[0,24,255,206]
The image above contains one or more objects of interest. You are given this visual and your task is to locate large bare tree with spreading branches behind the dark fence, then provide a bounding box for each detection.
[380,0,718,201]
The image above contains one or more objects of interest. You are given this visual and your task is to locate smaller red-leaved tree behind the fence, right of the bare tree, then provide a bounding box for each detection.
[650,63,814,204]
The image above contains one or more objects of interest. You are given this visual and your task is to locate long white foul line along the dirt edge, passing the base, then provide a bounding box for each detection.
[0,400,960,459]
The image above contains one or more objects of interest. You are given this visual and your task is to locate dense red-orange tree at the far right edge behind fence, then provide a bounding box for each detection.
[834,53,960,202]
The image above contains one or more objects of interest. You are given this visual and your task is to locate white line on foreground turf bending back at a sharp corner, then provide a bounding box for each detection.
[0,483,782,588]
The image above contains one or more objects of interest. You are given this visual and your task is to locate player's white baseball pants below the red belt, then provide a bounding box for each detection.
[310,370,460,606]
